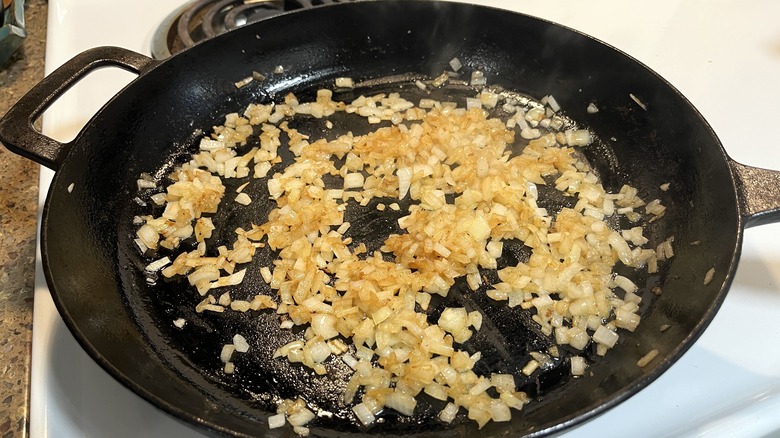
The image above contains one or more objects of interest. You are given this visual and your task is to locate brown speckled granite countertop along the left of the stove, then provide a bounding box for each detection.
[0,0,47,438]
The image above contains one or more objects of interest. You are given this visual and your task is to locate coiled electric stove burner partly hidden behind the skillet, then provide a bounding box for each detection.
[152,0,352,59]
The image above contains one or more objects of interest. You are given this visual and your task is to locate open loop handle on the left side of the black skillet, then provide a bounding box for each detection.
[0,46,157,170]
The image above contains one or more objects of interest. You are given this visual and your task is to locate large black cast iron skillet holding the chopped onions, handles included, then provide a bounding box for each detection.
[0,1,780,437]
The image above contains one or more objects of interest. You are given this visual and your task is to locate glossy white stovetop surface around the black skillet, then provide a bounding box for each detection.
[30,0,780,438]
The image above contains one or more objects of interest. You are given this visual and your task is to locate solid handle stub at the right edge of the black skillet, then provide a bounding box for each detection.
[729,159,780,228]
